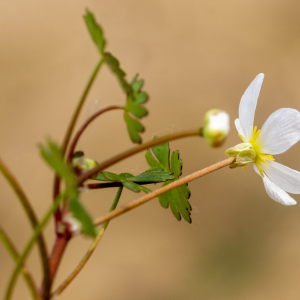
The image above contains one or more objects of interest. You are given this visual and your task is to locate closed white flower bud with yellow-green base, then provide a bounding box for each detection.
[203,109,230,147]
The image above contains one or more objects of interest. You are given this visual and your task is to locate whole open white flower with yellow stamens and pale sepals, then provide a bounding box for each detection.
[225,74,300,205]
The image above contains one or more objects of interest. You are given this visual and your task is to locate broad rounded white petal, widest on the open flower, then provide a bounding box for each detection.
[257,108,300,155]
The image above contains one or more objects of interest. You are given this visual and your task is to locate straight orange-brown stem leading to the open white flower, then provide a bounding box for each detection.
[94,157,235,225]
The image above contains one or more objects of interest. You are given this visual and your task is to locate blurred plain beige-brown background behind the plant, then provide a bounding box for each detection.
[0,0,300,300]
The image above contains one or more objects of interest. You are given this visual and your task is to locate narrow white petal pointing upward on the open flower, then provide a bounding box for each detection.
[239,73,264,141]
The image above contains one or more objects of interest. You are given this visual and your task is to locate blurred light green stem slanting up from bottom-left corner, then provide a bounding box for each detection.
[5,194,64,300]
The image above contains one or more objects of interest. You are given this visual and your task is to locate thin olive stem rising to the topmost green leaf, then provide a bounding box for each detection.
[53,59,104,209]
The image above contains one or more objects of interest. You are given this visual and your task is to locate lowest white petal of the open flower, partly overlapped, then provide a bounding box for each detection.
[253,164,297,205]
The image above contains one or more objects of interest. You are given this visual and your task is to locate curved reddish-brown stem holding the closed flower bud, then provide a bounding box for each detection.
[77,129,202,186]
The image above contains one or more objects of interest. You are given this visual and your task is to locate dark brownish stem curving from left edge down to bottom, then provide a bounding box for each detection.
[0,159,51,299]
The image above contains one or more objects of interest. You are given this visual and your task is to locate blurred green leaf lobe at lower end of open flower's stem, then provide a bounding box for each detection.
[69,198,96,237]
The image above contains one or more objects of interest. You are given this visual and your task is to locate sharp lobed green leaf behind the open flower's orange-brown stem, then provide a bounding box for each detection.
[146,137,192,223]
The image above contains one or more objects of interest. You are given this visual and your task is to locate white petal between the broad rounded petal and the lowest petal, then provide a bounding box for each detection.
[261,160,300,194]
